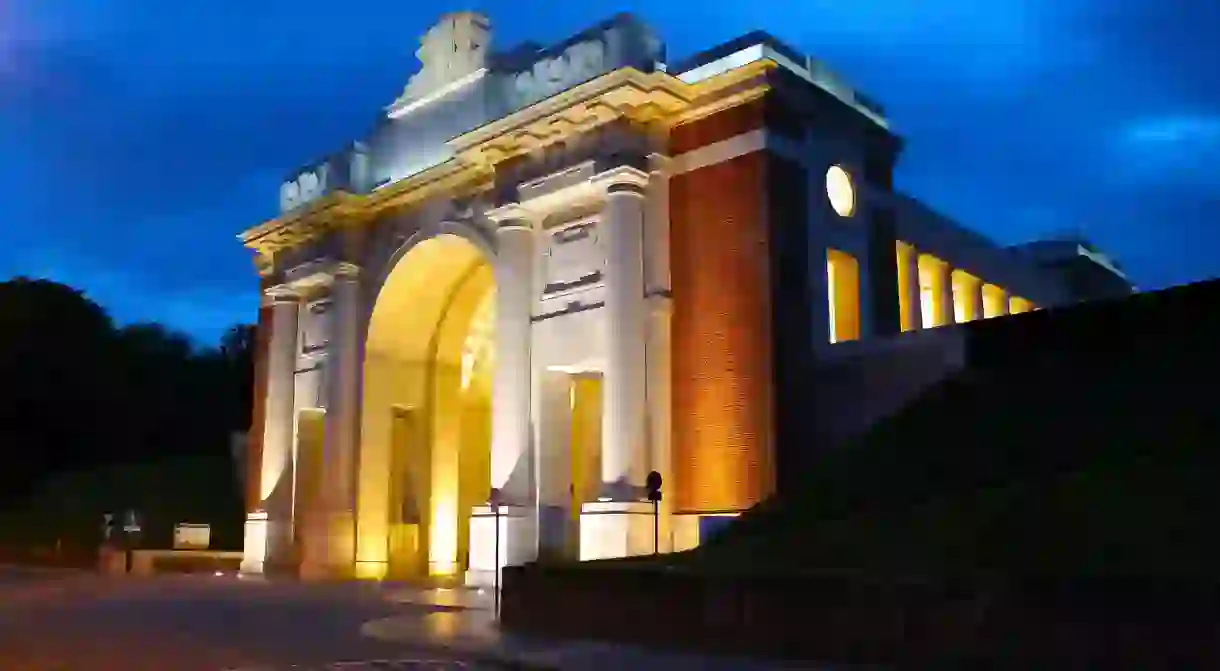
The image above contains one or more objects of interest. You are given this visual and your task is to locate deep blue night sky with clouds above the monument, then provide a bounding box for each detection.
[0,0,1220,342]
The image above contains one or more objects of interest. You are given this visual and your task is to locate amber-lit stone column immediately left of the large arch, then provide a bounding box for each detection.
[301,264,362,578]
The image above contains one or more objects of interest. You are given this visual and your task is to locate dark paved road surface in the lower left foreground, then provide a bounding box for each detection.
[0,570,500,671]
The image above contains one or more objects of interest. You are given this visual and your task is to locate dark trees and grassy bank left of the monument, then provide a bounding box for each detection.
[0,278,253,551]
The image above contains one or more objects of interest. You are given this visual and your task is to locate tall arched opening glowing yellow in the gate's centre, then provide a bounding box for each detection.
[356,234,495,577]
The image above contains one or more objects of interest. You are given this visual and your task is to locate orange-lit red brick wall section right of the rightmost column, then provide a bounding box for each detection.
[670,102,775,512]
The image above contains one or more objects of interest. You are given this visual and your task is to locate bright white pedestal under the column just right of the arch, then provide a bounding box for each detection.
[466,505,538,587]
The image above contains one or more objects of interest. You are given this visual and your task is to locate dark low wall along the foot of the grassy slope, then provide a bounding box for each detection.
[501,566,1220,669]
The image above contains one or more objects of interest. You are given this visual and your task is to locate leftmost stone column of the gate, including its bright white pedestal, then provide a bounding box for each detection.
[242,288,300,573]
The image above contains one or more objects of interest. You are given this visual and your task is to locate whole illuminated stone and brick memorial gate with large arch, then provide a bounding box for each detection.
[233,12,1127,583]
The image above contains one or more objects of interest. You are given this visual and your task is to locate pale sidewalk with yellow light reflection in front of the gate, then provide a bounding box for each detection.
[360,587,834,671]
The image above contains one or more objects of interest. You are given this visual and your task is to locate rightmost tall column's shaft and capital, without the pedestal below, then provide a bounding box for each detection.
[599,167,649,501]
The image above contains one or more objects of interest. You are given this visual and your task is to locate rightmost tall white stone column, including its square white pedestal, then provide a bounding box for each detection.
[581,166,653,559]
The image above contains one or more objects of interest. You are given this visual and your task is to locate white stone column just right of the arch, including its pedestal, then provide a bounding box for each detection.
[466,204,538,586]
